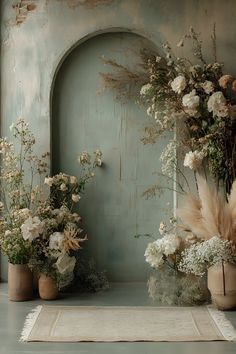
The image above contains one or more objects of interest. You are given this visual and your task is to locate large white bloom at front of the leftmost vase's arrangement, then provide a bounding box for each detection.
[21,216,44,242]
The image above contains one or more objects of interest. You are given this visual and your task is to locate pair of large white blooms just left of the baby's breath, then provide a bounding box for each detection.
[144,234,180,268]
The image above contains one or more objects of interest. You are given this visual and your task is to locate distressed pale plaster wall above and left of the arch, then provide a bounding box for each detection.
[1,0,236,278]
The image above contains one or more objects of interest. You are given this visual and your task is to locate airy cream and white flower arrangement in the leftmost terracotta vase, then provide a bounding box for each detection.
[0,119,48,264]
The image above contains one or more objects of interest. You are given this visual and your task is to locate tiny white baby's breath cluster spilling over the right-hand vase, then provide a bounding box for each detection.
[178,236,236,276]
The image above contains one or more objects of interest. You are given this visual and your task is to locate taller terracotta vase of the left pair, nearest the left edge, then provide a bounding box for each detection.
[8,263,33,301]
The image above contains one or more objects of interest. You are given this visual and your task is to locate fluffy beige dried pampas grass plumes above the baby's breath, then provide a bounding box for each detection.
[177,176,236,243]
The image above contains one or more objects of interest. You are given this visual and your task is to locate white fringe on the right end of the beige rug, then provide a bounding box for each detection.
[207,305,236,341]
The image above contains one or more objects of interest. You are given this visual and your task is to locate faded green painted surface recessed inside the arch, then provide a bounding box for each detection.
[52,33,171,281]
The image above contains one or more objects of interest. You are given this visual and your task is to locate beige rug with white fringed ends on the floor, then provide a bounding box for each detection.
[21,306,236,342]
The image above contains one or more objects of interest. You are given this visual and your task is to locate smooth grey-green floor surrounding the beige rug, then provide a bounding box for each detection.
[0,283,236,354]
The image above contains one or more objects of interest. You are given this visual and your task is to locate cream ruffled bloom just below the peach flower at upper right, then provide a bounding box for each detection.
[207,91,229,117]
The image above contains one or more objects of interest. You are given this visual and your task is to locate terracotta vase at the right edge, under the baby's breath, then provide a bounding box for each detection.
[207,263,236,310]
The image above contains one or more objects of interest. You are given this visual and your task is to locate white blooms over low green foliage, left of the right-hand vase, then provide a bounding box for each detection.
[144,219,208,305]
